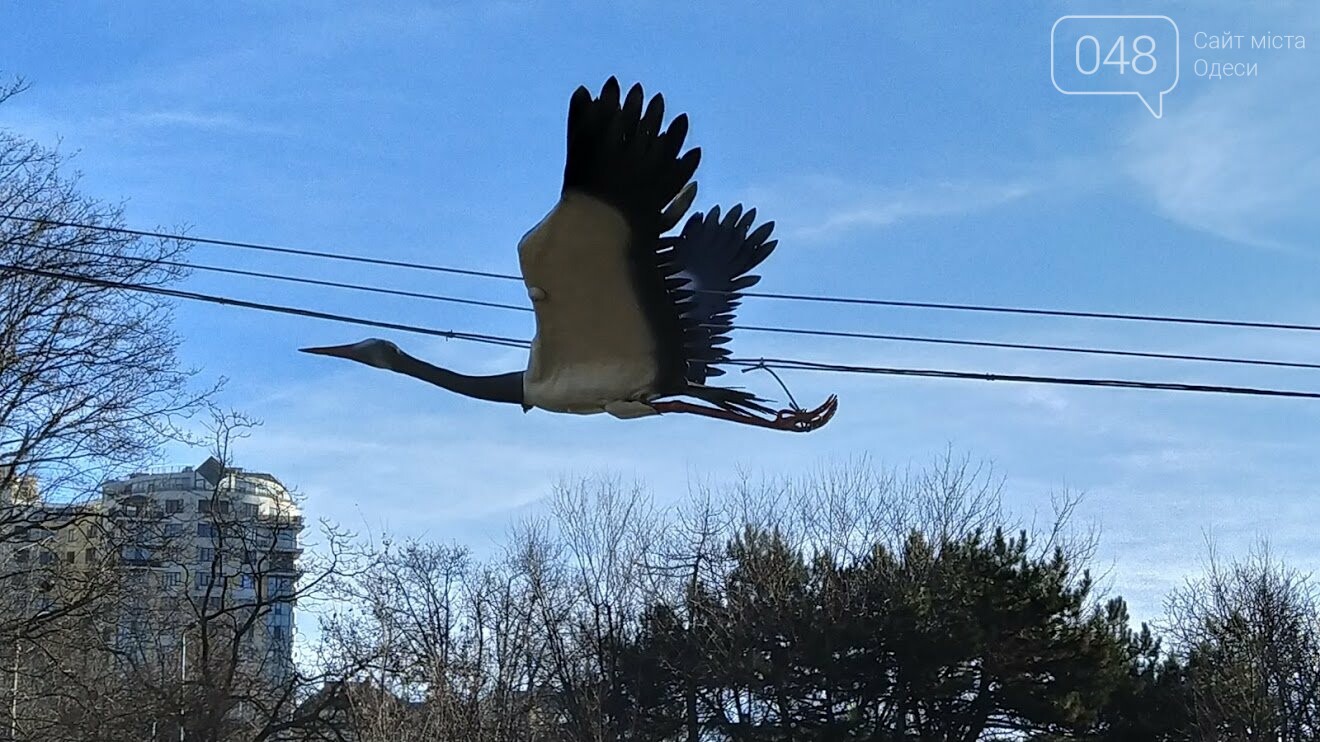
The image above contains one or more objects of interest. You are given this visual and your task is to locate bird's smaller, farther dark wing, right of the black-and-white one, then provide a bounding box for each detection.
[659,203,777,412]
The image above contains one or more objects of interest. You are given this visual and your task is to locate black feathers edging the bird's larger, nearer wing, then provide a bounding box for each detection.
[564,78,701,393]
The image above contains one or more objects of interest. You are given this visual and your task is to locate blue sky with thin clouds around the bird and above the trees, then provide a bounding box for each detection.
[0,1,1320,618]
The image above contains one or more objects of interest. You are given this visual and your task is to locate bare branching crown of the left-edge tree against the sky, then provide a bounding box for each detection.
[0,79,207,496]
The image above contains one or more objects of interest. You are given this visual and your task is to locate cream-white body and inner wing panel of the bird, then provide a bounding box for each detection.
[517,191,656,417]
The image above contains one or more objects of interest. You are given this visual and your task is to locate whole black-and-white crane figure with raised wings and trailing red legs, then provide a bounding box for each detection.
[301,78,838,432]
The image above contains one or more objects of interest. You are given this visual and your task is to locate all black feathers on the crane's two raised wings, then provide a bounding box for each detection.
[564,78,775,413]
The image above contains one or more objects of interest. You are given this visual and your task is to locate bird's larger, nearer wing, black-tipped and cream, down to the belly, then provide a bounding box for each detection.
[519,78,701,409]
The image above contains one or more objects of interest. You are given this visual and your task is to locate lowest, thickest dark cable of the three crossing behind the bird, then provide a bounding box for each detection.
[12,257,1320,399]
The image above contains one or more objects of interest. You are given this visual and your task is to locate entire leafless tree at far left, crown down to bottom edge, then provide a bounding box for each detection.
[0,75,214,737]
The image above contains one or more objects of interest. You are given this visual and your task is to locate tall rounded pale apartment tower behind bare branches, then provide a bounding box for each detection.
[97,458,304,680]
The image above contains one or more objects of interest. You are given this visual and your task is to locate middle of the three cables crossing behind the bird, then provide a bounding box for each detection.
[16,242,1320,370]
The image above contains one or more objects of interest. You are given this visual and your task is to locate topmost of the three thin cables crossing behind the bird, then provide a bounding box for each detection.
[0,214,1320,333]
